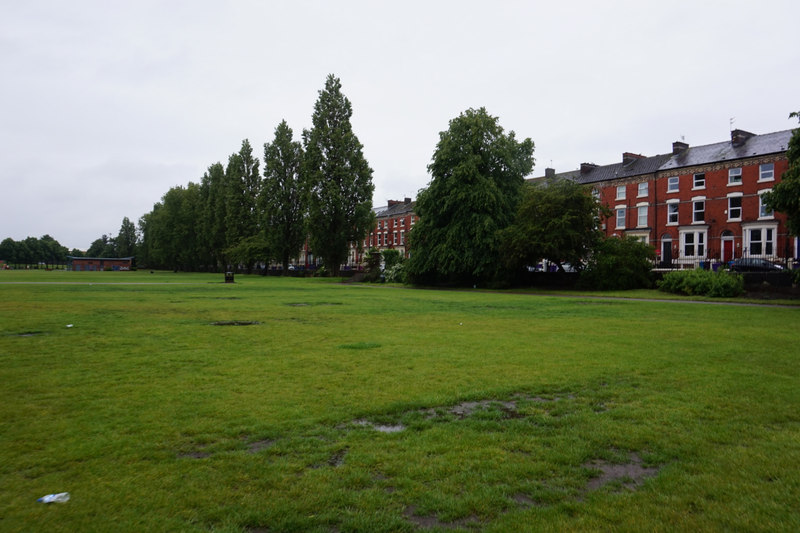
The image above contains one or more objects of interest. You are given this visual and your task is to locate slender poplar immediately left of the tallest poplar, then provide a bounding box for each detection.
[260,120,306,273]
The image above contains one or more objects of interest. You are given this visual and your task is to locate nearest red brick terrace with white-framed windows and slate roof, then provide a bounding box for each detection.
[535,129,798,268]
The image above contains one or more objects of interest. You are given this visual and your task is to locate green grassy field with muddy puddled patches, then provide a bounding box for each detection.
[0,272,800,532]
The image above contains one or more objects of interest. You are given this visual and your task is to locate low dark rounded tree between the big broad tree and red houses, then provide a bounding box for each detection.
[501,180,607,271]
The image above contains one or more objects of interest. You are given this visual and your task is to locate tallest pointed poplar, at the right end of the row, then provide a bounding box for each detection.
[302,74,374,276]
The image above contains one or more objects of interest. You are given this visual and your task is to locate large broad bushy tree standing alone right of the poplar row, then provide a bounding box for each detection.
[406,108,534,285]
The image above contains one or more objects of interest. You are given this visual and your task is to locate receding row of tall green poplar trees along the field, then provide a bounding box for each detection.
[137,75,374,275]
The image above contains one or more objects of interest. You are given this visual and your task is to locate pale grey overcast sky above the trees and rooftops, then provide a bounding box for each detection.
[0,0,800,250]
